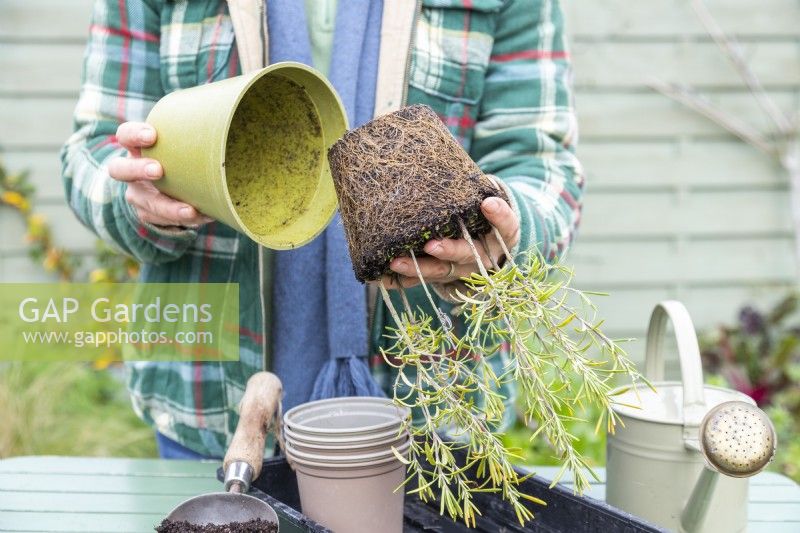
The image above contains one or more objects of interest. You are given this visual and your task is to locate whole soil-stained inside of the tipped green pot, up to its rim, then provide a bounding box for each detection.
[225,69,347,249]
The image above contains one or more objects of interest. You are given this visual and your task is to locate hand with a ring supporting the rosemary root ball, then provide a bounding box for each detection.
[382,196,519,288]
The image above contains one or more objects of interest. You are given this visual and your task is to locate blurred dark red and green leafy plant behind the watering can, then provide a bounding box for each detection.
[701,293,800,481]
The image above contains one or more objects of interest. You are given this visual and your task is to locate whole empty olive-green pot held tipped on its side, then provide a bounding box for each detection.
[142,62,347,250]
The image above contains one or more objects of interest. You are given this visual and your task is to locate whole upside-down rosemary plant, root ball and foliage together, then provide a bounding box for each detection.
[329,105,641,524]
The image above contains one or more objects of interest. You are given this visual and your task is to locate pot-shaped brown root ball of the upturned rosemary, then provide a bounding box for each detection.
[328,105,508,281]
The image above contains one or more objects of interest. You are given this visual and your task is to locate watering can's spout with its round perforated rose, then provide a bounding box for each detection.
[681,401,776,533]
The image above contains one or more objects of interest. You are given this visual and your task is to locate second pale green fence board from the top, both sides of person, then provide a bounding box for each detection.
[6,40,800,95]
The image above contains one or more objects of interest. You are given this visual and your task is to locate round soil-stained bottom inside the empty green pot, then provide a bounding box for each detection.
[225,76,324,236]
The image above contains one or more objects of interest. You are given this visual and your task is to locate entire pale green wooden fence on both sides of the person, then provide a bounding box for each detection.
[0,0,800,353]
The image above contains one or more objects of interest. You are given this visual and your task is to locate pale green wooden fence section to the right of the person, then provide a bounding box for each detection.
[564,0,800,354]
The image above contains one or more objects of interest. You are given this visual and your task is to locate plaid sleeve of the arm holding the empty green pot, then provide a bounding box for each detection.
[61,0,197,263]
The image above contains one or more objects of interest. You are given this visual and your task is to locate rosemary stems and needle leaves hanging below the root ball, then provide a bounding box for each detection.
[380,219,643,526]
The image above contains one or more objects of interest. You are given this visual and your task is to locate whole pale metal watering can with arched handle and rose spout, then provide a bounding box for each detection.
[606,301,776,533]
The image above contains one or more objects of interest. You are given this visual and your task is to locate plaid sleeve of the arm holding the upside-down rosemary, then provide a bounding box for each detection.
[471,0,584,261]
